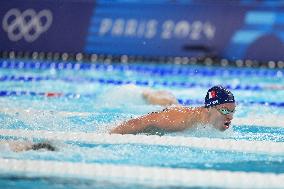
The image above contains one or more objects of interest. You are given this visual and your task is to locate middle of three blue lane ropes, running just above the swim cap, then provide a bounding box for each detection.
[0,75,266,91]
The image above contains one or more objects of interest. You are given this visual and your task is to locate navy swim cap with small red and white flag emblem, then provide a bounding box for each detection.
[205,86,235,108]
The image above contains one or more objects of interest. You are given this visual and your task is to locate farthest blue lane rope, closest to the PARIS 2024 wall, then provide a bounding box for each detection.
[0,59,284,77]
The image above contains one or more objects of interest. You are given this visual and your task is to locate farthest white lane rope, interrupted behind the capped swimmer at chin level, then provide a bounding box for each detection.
[0,108,284,128]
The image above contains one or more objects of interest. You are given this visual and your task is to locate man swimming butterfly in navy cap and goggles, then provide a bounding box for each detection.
[110,86,236,134]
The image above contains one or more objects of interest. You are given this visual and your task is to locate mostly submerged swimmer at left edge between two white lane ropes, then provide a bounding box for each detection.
[0,140,56,152]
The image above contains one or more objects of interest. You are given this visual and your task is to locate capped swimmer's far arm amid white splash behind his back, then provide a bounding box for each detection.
[142,89,178,106]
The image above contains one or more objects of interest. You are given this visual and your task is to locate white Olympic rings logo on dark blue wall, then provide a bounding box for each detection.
[2,9,52,42]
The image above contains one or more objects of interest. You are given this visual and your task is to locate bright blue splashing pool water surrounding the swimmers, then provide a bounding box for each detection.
[0,60,284,189]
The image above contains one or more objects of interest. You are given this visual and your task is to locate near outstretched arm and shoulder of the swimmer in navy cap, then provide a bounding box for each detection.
[110,107,191,134]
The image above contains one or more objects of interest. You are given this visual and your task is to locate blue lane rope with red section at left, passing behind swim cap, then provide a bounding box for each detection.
[0,90,284,107]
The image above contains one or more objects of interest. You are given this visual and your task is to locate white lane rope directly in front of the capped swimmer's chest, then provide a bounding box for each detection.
[0,129,284,154]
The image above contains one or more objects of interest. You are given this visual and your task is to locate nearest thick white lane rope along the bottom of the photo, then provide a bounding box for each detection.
[0,159,284,188]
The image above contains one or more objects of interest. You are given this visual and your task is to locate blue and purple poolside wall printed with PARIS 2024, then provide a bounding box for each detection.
[0,0,284,61]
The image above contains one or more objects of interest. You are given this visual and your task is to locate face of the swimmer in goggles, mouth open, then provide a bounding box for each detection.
[210,103,236,131]
